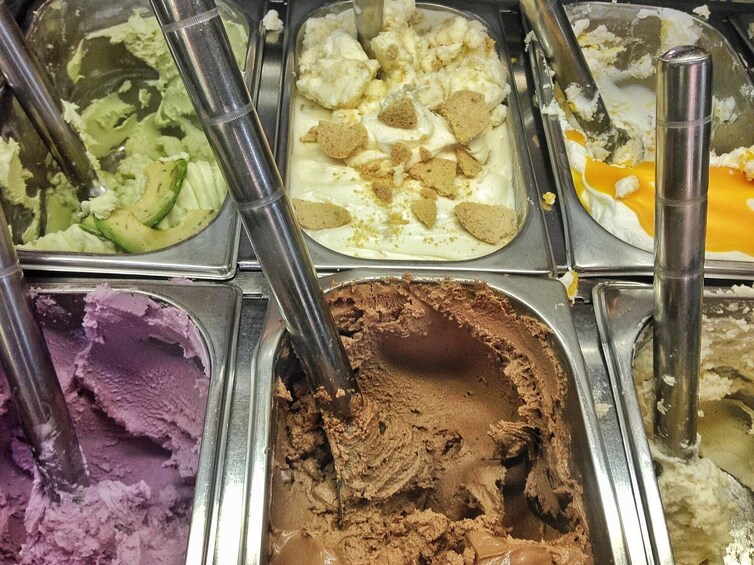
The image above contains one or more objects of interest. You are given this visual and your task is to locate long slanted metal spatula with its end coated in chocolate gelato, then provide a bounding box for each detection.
[151,0,428,512]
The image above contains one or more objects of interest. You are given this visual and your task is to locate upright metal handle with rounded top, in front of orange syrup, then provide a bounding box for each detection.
[654,46,712,458]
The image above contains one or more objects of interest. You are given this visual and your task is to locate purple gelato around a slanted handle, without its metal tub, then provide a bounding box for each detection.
[0,287,209,565]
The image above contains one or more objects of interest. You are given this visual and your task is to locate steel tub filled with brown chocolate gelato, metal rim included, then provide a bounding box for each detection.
[234,270,634,563]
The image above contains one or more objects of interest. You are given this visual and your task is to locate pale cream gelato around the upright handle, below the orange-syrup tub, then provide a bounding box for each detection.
[634,304,754,565]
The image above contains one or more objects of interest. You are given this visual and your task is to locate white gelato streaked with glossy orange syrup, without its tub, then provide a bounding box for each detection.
[543,8,754,261]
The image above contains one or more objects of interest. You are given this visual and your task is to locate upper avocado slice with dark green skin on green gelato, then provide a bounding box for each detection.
[130,159,188,227]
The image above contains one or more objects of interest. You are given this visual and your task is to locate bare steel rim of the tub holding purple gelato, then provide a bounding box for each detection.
[25,279,242,565]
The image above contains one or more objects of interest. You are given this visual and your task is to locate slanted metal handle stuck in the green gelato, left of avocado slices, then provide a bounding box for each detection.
[0,0,101,200]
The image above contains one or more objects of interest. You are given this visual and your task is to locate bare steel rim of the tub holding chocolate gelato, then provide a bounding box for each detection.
[238,269,624,564]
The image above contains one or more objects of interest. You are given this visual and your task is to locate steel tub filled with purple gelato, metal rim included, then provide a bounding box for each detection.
[0,279,242,563]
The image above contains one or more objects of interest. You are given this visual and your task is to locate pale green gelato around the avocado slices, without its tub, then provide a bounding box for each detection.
[0,13,247,253]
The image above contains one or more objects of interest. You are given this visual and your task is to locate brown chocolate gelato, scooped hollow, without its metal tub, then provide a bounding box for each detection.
[268,279,592,564]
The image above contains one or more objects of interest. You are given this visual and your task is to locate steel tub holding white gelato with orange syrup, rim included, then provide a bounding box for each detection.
[529,2,754,278]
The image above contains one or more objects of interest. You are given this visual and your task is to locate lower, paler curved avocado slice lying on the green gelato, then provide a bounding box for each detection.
[95,209,215,253]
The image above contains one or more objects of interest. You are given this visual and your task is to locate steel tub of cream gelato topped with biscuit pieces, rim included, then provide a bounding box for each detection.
[239,2,555,274]
